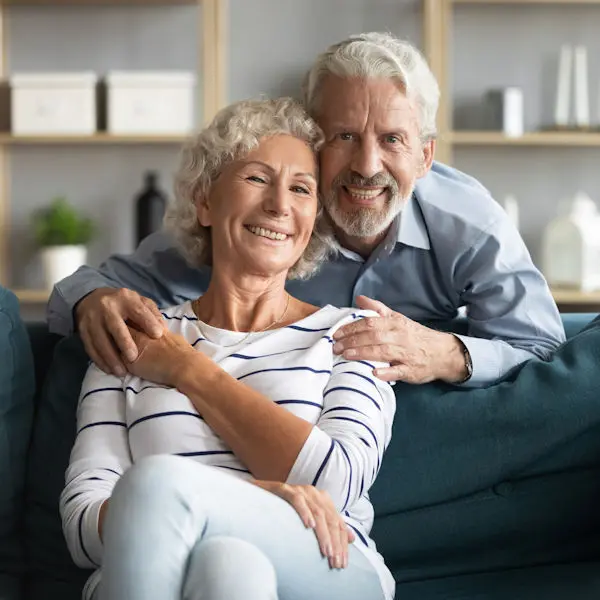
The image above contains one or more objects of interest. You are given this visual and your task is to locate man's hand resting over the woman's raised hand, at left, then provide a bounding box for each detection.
[75,288,164,377]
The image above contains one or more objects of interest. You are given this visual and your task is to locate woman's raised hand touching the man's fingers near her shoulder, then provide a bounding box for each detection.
[124,325,204,387]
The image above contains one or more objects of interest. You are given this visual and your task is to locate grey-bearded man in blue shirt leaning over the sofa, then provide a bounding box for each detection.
[48,33,564,386]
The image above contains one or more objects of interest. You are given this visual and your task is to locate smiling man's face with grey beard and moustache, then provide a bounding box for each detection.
[317,75,434,241]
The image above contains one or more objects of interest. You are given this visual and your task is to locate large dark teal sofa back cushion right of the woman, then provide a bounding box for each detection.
[371,318,600,581]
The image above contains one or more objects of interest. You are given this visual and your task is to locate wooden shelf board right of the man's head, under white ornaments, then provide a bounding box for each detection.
[444,131,600,147]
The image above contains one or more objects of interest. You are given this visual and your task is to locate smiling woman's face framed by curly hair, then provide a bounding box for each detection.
[197,135,317,277]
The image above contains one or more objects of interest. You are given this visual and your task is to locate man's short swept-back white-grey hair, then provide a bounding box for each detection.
[304,32,440,141]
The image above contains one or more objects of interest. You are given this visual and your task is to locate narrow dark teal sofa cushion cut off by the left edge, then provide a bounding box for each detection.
[0,287,35,600]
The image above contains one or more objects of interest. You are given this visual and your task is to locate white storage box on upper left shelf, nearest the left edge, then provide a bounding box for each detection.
[10,72,98,135]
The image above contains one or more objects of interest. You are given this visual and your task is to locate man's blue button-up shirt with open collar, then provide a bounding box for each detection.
[48,163,565,386]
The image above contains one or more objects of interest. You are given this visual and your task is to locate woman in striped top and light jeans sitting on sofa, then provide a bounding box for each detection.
[60,99,395,600]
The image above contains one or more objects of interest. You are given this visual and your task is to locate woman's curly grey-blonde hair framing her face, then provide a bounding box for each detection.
[165,98,332,279]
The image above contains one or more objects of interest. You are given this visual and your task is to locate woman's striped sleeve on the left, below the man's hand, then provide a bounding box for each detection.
[60,365,131,568]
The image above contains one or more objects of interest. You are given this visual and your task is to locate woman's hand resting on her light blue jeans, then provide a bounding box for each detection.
[252,480,356,569]
